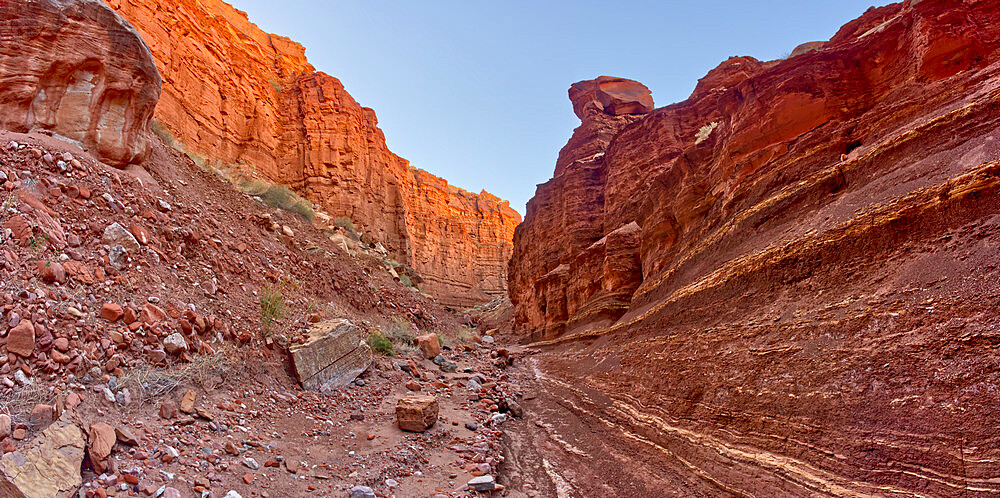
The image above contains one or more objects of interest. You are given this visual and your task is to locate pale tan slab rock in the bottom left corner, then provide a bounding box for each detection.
[0,420,86,498]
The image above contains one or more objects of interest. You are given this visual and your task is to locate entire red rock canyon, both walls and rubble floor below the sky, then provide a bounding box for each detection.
[0,0,1000,498]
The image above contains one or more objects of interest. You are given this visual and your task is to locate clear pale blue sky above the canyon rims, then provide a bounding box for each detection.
[230,0,889,214]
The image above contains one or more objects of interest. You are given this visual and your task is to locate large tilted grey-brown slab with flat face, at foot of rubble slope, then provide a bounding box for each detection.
[289,319,372,389]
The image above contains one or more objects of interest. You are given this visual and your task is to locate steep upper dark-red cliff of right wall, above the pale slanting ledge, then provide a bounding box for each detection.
[510,1,998,339]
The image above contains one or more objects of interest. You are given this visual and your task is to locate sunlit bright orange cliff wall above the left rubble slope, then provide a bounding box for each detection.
[107,0,521,306]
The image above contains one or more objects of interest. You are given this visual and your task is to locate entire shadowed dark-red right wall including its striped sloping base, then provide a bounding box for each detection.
[510,0,1000,496]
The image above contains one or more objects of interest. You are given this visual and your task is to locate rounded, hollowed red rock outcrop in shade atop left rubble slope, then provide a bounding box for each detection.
[0,0,160,166]
